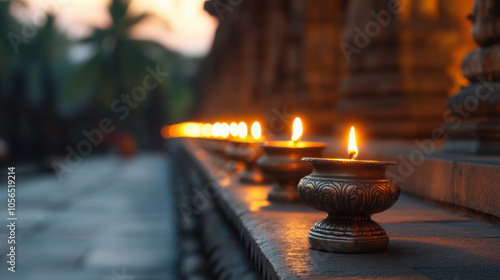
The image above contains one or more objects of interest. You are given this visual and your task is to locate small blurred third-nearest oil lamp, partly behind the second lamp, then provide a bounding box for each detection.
[226,122,265,184]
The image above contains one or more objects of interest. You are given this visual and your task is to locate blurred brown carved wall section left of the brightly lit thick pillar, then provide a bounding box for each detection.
[198,0,346,134]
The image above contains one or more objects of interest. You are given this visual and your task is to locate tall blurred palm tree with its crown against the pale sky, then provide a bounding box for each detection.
[63,0,176,150]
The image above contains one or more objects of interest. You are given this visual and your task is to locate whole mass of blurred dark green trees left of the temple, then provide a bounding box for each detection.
[0,0,203,160]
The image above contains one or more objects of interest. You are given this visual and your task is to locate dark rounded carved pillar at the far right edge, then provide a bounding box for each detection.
[443,0,500,154]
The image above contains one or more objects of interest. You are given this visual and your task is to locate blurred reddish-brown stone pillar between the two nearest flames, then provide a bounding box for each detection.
[299,0,347,134]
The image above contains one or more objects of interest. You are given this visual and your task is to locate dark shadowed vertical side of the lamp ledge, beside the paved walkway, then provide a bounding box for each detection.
[173,142,259,280]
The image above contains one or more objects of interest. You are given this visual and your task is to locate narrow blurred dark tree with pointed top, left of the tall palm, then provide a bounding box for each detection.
[22,14,71,158]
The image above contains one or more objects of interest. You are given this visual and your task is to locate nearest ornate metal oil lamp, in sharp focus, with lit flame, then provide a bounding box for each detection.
[298,127,400,253]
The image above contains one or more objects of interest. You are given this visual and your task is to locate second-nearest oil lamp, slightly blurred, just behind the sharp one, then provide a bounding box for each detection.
[257,118,327,202]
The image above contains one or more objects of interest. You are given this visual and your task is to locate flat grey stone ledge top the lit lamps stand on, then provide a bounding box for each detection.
[184,141,500,279]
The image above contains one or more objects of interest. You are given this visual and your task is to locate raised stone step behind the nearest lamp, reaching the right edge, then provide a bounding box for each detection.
[358,142,500,218]
